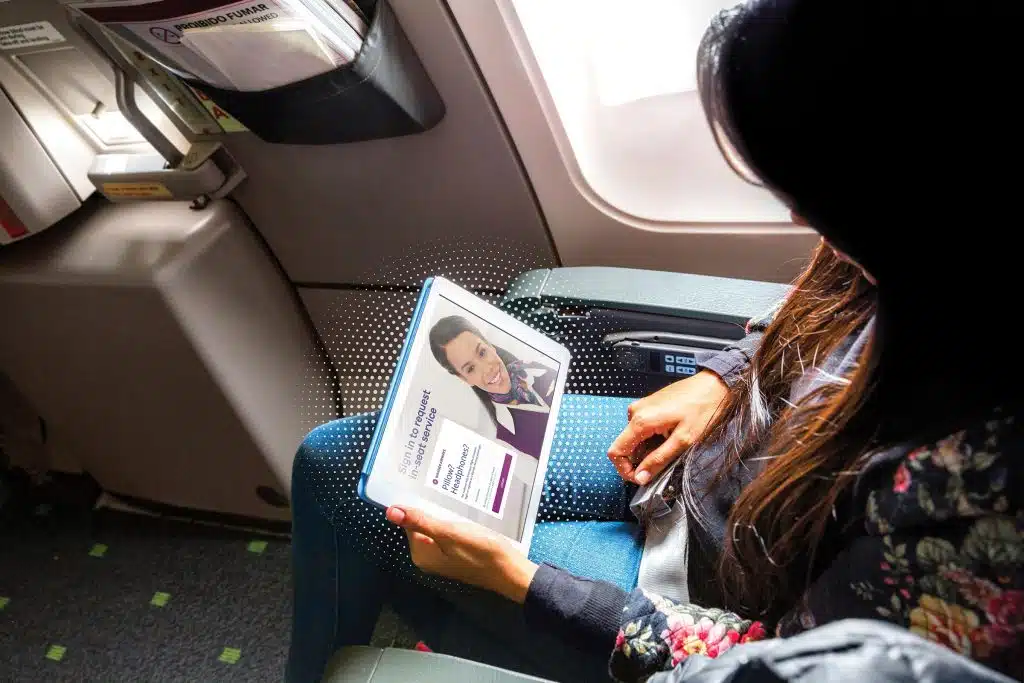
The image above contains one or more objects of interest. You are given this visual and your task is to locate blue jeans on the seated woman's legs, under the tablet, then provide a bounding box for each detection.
[287,395,643,683]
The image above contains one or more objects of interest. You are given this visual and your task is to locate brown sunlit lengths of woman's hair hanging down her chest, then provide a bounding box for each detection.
[681,244,874,621]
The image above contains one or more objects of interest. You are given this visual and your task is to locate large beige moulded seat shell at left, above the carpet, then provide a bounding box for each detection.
[0,198,334,520]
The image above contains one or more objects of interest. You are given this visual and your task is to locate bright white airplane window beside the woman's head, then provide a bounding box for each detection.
[508,0,790,223]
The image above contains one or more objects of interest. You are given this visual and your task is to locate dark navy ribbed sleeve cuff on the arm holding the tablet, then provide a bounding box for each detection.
[524,564,628,652]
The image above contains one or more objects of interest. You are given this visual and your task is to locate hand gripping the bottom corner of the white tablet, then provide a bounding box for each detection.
[387,507,537,604]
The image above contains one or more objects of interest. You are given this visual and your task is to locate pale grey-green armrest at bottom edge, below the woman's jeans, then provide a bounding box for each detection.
[323,647,545,683]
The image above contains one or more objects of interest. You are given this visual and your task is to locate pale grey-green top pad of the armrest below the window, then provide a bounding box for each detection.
[503,267,790,326]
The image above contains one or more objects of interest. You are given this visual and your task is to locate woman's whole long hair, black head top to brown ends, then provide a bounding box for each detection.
[688,0,1024,621]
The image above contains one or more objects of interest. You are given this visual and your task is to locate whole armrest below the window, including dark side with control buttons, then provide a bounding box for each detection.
[502,267,790,396]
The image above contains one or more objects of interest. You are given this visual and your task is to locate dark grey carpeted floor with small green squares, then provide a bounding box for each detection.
[0,497,291,683]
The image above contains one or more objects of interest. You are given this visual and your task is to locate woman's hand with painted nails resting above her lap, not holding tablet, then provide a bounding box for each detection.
[608,370,729,485]
